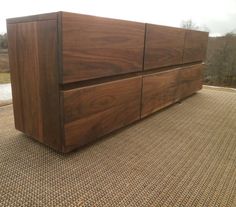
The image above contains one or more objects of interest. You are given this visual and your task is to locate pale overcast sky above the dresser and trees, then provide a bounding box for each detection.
[0,0,236,36]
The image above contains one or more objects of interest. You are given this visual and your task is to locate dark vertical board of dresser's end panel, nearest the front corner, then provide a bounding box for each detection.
[37,20,62,149]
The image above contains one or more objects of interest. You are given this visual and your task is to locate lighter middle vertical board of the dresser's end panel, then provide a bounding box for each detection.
[16,22,43,141]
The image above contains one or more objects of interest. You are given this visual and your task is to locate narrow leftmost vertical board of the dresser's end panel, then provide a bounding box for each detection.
[7,24,24,131]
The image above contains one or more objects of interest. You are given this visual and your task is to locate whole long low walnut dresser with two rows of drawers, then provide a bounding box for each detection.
[7,12,208,152]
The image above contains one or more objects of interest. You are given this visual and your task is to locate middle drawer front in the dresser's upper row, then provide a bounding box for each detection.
[144,24,185,70]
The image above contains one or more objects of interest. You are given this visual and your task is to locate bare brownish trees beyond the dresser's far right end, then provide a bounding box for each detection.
[204,33,236,87]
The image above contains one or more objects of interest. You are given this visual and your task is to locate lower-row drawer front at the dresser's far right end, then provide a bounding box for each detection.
[178,64,203,99]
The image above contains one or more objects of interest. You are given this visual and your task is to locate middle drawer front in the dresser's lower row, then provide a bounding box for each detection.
[141,69,179,117]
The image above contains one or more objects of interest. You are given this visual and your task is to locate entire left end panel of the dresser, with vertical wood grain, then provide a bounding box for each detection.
[8,20,61,150]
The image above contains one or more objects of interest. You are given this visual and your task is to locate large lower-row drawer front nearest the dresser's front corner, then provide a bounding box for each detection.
[61,76,142,148]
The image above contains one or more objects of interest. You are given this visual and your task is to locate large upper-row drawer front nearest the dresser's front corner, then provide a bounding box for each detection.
[62,12,145,83]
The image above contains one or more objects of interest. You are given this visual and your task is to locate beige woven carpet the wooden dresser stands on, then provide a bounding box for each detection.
[0,89,236,207]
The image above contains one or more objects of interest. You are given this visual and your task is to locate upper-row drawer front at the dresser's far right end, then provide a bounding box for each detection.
[183,30,208,63]
